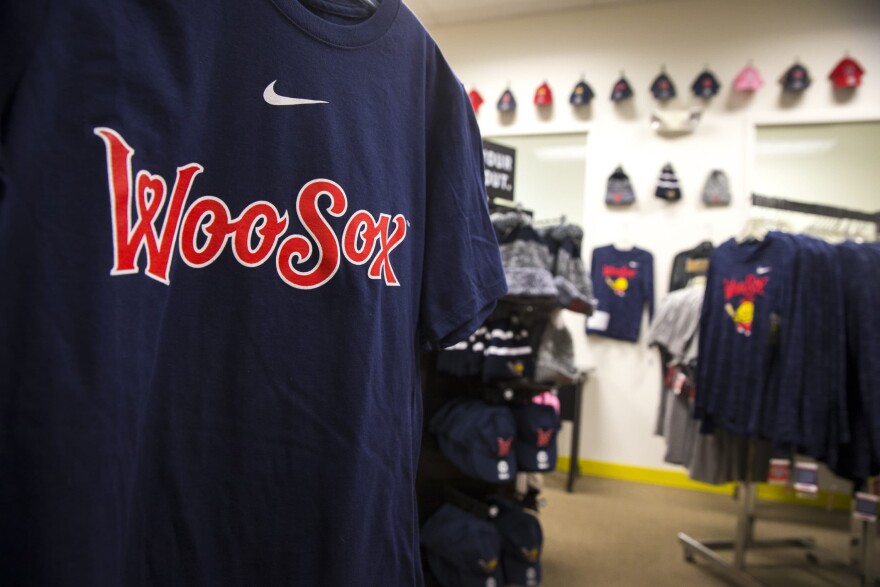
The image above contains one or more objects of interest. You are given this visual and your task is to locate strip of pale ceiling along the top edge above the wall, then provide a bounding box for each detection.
[404,0,669,27]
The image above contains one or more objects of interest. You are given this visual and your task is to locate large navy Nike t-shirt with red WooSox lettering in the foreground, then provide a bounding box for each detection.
[0,0,506,586]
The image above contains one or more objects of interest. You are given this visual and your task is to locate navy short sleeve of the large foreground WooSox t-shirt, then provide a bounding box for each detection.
[419,52,507,348]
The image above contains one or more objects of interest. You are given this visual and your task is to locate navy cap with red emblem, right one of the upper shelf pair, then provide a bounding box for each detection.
[512,404,561,471]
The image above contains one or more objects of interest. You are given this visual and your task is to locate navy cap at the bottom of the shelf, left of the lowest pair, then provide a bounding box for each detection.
[421,504,504,587]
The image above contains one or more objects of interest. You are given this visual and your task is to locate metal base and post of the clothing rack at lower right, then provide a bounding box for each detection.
[678,441,878,587]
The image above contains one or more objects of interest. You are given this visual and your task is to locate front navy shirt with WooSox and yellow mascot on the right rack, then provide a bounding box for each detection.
[695,233,804,441]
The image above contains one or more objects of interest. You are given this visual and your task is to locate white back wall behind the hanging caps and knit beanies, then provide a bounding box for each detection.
[422,0,880,467]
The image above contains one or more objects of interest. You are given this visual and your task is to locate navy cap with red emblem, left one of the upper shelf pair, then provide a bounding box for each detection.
[430,398,516,483]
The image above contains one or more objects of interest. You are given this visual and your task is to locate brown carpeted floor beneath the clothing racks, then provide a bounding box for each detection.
[541,473,872,587]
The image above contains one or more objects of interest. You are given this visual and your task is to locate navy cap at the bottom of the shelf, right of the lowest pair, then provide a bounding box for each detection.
[492,498,544,587]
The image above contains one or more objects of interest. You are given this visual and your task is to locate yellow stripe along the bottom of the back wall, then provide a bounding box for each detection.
[556,455,852,511]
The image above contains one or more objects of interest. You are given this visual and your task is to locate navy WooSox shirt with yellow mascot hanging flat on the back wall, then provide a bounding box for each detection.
[587,245,654,342]
